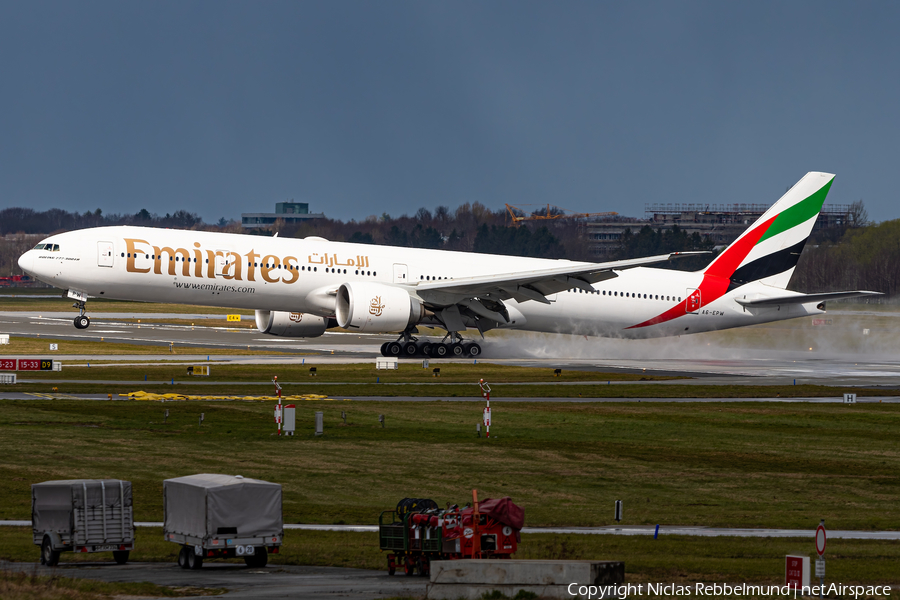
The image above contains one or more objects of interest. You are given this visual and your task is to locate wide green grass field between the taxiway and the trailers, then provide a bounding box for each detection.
[0,400,900,529]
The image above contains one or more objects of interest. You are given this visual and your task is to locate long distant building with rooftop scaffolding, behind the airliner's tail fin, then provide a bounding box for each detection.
[584,203,850,257]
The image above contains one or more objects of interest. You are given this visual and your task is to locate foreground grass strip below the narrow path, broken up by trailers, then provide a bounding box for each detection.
[0,527,900,585]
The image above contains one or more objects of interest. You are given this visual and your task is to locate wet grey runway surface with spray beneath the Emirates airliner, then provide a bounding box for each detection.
[0,311,900,389]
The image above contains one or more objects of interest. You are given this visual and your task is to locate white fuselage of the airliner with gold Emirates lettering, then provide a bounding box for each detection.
[19,226,822,337]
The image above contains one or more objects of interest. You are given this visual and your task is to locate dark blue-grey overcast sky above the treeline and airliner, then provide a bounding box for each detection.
[0,0,900,221]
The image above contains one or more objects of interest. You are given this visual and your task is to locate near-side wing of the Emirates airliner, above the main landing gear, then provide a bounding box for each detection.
[413,252,708,316]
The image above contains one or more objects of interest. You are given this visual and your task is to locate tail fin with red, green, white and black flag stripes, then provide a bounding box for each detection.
[704,172,834,290]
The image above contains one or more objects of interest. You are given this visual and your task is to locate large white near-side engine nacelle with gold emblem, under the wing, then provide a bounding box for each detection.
[335,281,425,333]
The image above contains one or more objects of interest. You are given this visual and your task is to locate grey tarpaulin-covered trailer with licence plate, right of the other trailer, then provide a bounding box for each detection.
[163,473,284,569]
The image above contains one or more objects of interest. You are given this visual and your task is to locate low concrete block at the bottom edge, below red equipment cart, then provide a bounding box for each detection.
[425,559,625,600]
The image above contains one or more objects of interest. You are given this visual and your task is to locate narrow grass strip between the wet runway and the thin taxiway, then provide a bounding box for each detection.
[9,359,897,399]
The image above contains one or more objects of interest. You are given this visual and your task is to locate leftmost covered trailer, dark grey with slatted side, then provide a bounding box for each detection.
[31,479,134,566]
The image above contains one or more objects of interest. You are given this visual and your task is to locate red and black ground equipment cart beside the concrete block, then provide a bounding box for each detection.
[378,490,525,576]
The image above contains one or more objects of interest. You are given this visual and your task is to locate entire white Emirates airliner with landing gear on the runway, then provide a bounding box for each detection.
[19,172,877,356]
